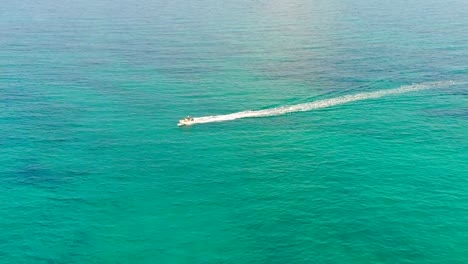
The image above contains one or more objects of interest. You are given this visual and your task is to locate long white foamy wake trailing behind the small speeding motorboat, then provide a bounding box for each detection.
[189,81,460,124]
